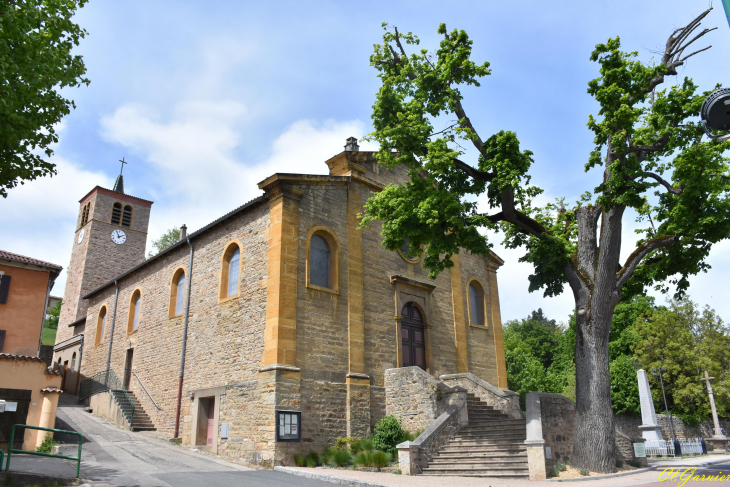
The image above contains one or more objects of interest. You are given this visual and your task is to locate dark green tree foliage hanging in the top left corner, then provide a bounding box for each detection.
[0,0,89,198]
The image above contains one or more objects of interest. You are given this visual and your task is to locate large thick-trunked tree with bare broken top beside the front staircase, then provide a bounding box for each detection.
[362,11,730,472]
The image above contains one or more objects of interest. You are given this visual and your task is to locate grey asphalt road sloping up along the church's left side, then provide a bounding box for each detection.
[4,395,334,487]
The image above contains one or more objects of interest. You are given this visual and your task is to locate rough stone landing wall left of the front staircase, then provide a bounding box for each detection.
[385,367,468,432]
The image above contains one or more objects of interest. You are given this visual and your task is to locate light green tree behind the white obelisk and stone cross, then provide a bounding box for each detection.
[635,300,730,423]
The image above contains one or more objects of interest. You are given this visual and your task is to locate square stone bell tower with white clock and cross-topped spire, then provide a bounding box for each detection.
[56,166,152,343]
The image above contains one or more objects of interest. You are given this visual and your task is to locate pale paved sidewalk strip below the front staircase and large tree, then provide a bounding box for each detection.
[282,455,730,487]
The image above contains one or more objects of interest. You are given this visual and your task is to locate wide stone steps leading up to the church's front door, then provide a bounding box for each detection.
[423,394,529,478]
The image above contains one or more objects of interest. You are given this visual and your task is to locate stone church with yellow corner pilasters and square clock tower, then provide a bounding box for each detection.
[54,138,507,466]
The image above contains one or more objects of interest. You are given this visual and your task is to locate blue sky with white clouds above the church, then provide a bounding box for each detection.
[0,0,730,321]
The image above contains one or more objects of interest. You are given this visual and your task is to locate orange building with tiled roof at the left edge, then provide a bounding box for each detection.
[0,250,62,451]
